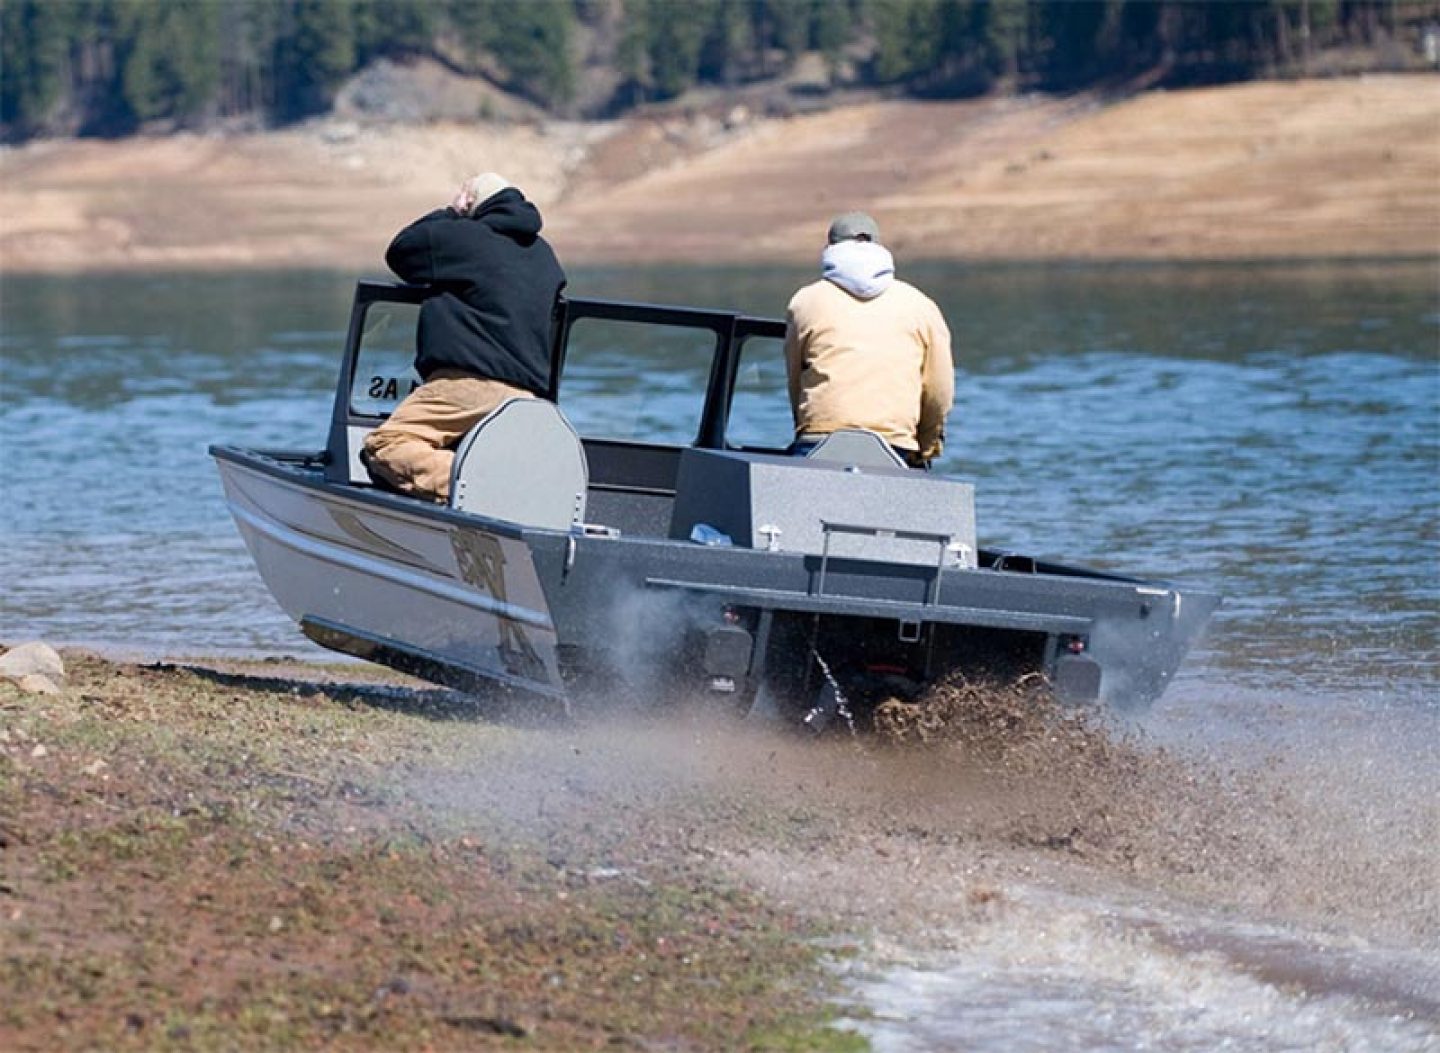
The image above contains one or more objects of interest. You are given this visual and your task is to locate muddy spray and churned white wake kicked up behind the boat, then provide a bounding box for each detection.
[406,683,1440,1050]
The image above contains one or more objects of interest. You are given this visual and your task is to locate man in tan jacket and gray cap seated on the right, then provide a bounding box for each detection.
[785,212,955,467]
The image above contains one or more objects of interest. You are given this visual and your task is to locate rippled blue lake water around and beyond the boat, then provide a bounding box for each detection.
[0,264,1440,700]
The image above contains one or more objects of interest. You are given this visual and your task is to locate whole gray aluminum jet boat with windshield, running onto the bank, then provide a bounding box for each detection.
[210,282,1220,716]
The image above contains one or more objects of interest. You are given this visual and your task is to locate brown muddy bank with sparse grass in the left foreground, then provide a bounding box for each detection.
[0,654,857,1052]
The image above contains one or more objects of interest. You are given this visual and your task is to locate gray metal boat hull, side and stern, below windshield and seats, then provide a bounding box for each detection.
[212,447,1218,717]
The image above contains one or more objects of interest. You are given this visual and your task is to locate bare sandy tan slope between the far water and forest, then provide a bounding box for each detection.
[0,75,1440,272]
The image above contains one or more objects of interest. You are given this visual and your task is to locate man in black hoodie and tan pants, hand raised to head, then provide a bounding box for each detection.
[360,171,564,503]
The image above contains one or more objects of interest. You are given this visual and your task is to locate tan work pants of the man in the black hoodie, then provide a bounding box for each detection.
[360,369,534,503]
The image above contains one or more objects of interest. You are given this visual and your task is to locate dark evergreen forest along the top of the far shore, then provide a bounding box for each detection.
[0,0,1440,141]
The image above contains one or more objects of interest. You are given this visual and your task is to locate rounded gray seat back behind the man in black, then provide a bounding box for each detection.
[449,399,590,530]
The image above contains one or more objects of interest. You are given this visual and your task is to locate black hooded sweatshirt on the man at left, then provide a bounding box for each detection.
[384,187,564,395]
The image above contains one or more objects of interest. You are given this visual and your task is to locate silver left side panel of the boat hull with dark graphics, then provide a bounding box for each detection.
[217,454,564,697]
